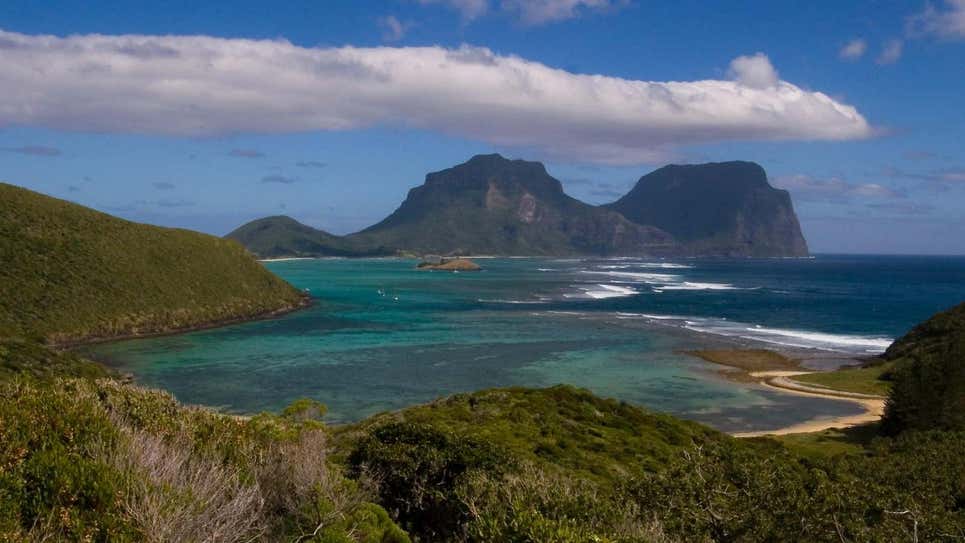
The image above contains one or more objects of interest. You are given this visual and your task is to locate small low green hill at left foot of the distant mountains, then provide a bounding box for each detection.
[225,215,394,258]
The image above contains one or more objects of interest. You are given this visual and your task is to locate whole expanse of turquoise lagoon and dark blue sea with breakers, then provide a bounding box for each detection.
[86,256,965,431]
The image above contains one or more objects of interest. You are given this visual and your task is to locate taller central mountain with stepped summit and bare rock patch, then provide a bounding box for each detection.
[349,155,674,255]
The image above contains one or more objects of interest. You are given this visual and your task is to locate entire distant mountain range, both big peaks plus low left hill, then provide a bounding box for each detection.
[228,154,808,257]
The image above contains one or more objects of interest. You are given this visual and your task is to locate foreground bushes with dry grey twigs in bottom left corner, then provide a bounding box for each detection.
[0,379,408,543]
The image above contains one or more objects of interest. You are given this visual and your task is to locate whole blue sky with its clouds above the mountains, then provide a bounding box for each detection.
[0,0,965,254]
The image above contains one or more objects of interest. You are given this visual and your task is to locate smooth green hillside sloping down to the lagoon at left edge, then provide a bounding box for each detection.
[0,183,302,342]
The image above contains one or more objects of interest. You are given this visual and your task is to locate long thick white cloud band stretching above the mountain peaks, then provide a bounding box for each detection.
[0,31,872,164]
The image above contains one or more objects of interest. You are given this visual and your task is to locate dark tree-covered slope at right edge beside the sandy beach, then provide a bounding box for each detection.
[882,303,965,434]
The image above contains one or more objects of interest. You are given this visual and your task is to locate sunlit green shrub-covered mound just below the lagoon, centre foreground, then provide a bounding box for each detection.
[340,385,732,483]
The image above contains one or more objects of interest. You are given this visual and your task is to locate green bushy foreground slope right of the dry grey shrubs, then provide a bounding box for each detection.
[344,386,965,543]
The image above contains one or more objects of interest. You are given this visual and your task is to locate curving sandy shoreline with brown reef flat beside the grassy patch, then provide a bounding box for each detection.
[686,349,886,438]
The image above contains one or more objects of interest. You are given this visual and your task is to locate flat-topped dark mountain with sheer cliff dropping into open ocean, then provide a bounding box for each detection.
[607,161,808,256]
